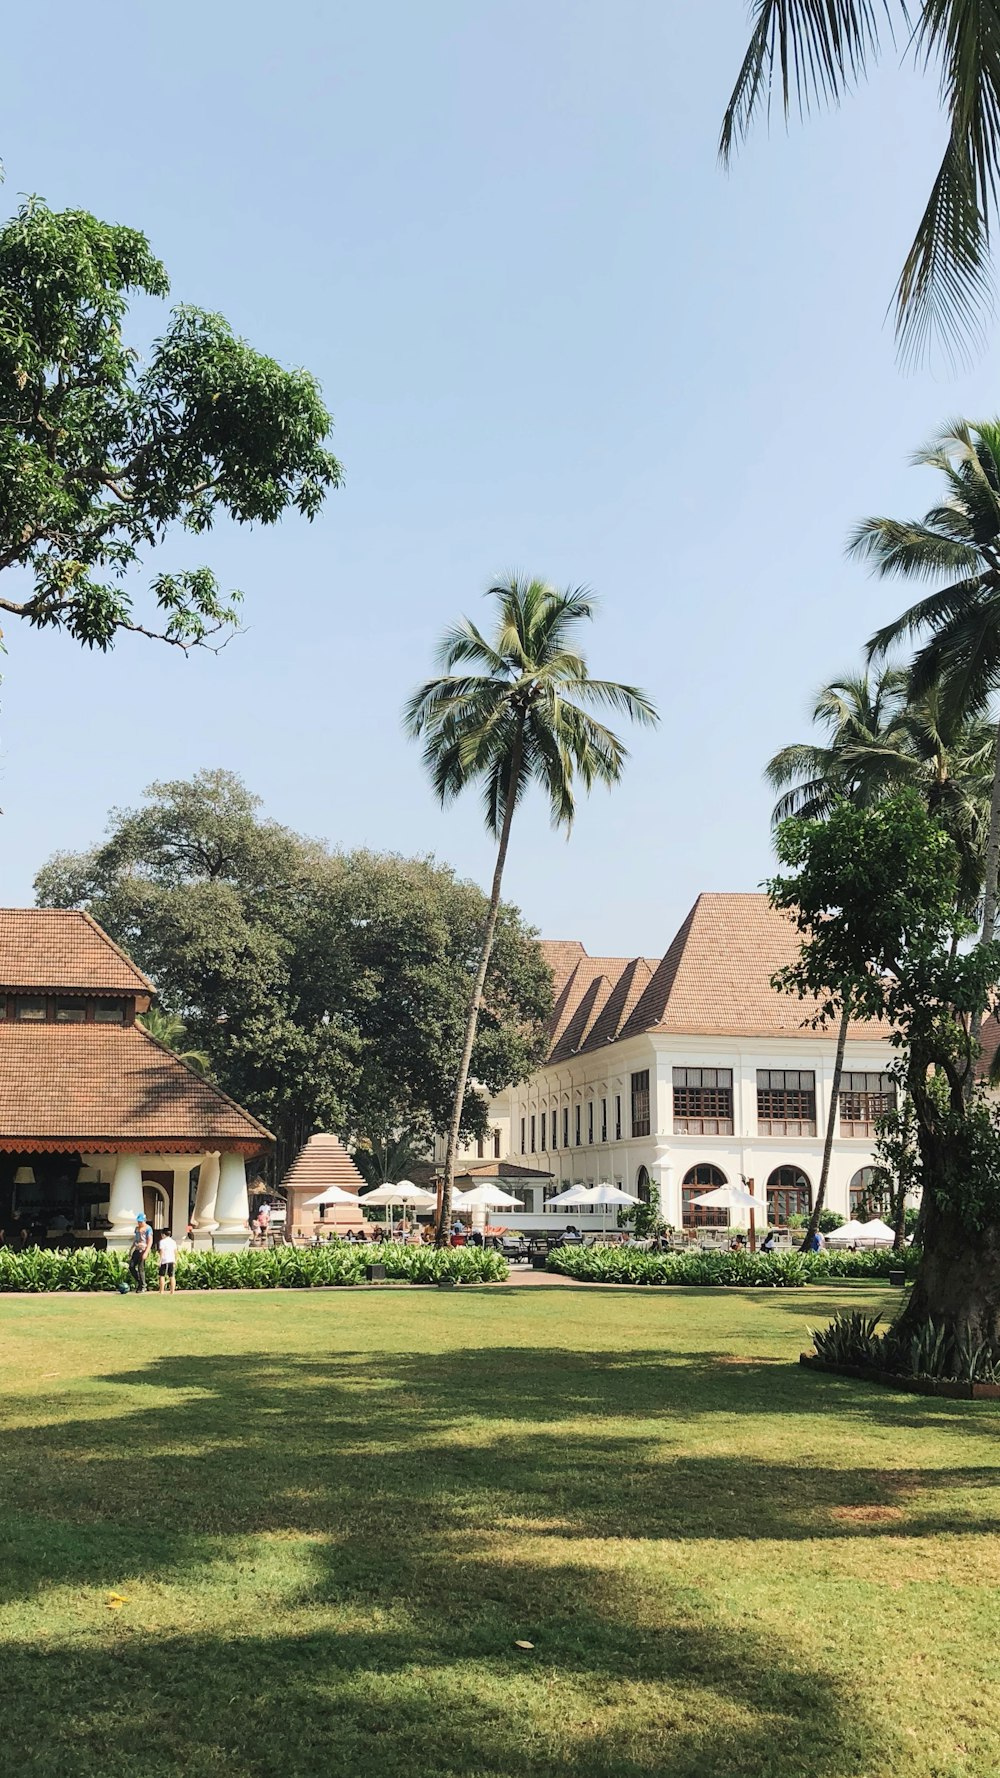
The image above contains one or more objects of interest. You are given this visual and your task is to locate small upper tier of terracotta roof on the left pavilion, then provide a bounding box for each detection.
[0,907,155,994]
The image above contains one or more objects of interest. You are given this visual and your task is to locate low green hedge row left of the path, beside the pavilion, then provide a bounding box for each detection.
[0,1241,507,1291]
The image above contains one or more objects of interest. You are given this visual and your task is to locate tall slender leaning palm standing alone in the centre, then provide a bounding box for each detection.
[406,574,658,1243]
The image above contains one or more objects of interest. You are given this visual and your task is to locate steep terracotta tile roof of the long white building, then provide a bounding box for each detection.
[543,894,886,1061]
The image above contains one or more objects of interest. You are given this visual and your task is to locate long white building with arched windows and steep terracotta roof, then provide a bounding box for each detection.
[448,894,895,1229]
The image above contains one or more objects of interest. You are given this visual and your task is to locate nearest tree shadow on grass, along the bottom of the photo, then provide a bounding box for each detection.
[4,1545,891,1778]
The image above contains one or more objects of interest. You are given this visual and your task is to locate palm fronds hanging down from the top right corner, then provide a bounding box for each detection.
[719,0,1000,357]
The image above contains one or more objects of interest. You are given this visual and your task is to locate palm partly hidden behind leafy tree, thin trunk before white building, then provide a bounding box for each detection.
[763,669,906,1252]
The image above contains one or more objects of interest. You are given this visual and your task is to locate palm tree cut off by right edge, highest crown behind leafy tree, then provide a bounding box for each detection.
[849,420,1000,981]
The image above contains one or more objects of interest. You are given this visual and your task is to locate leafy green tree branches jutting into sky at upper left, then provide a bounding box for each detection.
[0,197,340,649]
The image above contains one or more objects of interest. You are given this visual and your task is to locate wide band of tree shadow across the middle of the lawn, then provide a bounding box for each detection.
[0,1348,1000,1571]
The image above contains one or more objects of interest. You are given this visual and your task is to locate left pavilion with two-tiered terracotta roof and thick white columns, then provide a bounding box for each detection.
[0,909,272,1248]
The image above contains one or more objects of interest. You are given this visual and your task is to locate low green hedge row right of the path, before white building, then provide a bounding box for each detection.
[548,1246,918,1289]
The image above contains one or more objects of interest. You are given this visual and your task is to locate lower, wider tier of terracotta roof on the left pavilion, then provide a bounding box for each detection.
[0,1019,272,1149]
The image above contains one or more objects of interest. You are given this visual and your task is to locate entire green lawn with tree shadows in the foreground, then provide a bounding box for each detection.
[0,1285,1000,1778]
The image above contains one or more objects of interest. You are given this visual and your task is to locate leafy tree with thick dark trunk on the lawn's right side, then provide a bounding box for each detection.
[770,791,1000,1342]
